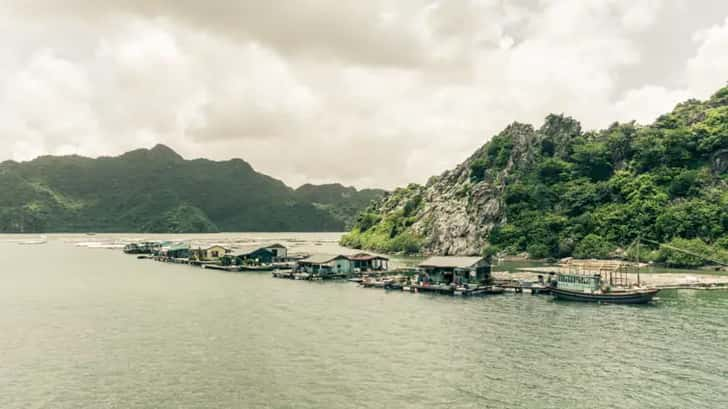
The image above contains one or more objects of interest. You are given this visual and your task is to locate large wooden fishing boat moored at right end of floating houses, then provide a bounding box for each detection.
[551,255,660,304]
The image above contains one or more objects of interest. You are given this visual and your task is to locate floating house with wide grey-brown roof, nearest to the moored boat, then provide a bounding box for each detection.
[417,256,490,285]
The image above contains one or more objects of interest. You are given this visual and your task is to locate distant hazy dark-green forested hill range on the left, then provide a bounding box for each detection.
[0,145,383,232]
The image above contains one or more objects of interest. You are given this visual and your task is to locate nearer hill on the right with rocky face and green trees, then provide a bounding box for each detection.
[342,87,728,264]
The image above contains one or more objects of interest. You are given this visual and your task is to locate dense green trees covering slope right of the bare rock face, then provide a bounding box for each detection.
[489,87,728,266]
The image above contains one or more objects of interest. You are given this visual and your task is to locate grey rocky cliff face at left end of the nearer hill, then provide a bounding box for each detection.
[343,115,580,255]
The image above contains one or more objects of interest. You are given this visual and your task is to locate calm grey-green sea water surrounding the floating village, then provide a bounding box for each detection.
[0,234,728,409]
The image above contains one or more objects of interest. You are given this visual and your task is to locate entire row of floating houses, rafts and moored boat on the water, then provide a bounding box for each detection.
[118,236,728,304]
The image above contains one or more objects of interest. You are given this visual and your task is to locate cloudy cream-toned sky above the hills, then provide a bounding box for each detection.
[0,0,728,189]
